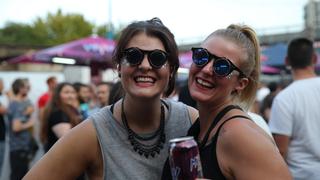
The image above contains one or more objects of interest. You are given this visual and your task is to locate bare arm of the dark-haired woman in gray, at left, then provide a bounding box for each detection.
[23,120,99,180]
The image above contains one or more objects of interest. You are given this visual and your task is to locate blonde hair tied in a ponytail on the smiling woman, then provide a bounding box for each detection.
[205,24,260,110]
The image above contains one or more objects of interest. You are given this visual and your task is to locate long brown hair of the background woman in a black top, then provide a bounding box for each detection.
[40,82,81,143]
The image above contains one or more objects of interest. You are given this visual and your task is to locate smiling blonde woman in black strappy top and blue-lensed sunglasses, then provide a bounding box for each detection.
[163,25,291,180]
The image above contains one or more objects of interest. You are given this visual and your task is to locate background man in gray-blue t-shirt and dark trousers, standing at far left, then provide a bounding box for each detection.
[8,79,35,180]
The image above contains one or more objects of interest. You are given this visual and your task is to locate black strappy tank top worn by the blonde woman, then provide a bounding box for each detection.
[162,105,250,180]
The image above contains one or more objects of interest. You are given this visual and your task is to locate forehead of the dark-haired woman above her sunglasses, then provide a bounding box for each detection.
[126,32,165,51]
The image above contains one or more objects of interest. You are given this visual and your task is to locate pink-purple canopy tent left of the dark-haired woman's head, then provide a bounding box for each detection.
[7,36,115,69]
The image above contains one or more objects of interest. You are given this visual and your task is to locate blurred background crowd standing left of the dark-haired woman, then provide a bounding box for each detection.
[0,76,121,179]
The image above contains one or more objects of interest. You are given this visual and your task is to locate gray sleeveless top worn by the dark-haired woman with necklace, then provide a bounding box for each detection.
[91,100,191,180]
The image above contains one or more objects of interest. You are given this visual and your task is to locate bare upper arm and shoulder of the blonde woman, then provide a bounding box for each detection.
[217,120,292,180]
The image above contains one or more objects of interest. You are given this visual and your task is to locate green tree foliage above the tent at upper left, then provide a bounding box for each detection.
[0,10,119,46]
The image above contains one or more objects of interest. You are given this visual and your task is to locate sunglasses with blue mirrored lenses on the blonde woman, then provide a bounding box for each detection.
[191,48,246,77]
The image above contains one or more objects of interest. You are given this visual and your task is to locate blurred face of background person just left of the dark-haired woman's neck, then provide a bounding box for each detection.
[97,82,113,108]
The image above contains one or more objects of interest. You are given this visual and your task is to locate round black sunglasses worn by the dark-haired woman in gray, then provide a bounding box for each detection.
[124,47,168,69]
